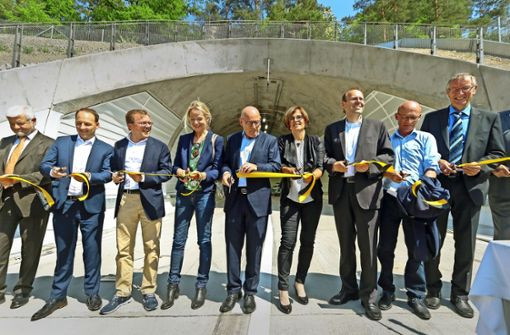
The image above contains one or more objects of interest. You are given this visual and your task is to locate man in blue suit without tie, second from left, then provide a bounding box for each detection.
[32,108,113,321]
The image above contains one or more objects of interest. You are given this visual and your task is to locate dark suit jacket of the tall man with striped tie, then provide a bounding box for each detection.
[421,107,505,206]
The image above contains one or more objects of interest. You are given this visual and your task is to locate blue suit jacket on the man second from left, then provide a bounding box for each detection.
[39,135,113,214]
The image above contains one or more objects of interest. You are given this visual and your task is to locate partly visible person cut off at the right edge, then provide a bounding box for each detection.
[489,111,510,240]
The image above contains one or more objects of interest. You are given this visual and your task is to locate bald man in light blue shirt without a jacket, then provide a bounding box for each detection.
[377,101,440,320]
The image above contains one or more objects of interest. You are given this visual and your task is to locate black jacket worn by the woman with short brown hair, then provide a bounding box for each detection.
[278,134,324,199]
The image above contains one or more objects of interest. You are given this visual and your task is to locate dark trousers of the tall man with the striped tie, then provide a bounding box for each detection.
[425,177,481,298]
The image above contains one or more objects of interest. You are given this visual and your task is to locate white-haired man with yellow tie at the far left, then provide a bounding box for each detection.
[0,106,53,309]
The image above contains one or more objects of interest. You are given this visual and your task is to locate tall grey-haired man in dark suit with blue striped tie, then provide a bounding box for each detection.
[421,73,504,318]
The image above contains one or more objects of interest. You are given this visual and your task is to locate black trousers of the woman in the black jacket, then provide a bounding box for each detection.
[278,196,322,291]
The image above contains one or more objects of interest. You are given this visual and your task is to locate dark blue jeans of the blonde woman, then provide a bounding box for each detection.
[168,192,215,287]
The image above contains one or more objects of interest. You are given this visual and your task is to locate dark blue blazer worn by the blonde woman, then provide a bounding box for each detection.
[172,131,224,193]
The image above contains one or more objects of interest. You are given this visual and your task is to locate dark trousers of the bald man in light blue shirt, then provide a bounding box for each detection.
[377,193,426,298]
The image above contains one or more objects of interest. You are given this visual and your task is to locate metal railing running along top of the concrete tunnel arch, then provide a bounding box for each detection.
[0,19,510,69]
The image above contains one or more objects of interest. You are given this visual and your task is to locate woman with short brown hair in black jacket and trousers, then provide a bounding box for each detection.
[278,106,324,314]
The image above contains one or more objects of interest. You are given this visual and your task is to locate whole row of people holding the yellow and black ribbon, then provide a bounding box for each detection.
[0,73,510,321]
